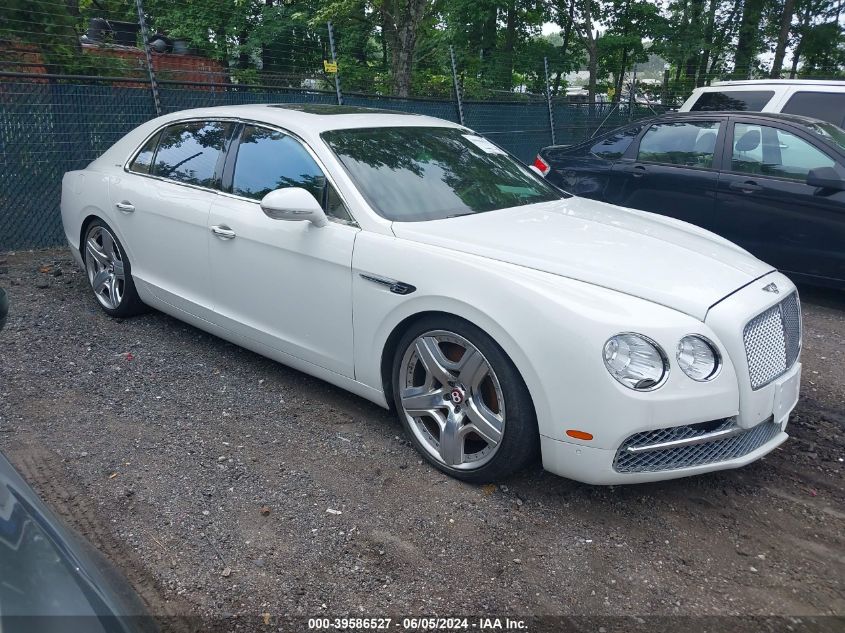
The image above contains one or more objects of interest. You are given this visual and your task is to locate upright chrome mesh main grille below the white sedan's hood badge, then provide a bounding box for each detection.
[742,292,801,389]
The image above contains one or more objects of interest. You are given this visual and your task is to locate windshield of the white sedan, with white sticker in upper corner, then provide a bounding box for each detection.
[322,127,564,222]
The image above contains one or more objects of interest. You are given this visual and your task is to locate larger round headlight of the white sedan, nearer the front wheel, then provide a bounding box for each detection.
[604,332,669,391]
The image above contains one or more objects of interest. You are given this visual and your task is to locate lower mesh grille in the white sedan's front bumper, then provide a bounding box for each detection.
[613,418,780,473]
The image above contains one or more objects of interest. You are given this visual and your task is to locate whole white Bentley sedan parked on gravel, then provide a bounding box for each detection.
[62,105,801,484]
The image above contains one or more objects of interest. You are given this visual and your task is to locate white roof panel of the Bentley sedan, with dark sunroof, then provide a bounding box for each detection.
[145,103,462,135]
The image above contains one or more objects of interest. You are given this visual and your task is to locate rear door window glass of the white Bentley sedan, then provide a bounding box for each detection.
[155,121,229,187]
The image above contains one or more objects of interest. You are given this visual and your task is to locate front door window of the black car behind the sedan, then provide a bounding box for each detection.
[731,123,835,180]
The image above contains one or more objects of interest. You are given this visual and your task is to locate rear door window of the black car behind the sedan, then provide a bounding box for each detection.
[637,121,719,167]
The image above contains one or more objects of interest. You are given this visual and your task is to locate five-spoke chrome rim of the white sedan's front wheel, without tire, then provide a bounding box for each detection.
[399,330,505,470]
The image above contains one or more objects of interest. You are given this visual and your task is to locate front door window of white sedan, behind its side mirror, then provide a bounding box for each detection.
[232,126,326,201]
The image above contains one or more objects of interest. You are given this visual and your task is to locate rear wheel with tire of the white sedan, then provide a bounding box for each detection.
[82,220,146,317]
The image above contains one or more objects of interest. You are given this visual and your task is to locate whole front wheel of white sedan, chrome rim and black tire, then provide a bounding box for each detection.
[393,316,539,482]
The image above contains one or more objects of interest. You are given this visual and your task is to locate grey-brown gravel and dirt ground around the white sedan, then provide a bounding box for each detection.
[0,251,845,621]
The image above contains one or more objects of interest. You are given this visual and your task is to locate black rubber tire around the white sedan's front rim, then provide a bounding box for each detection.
[392,315,540,483]
